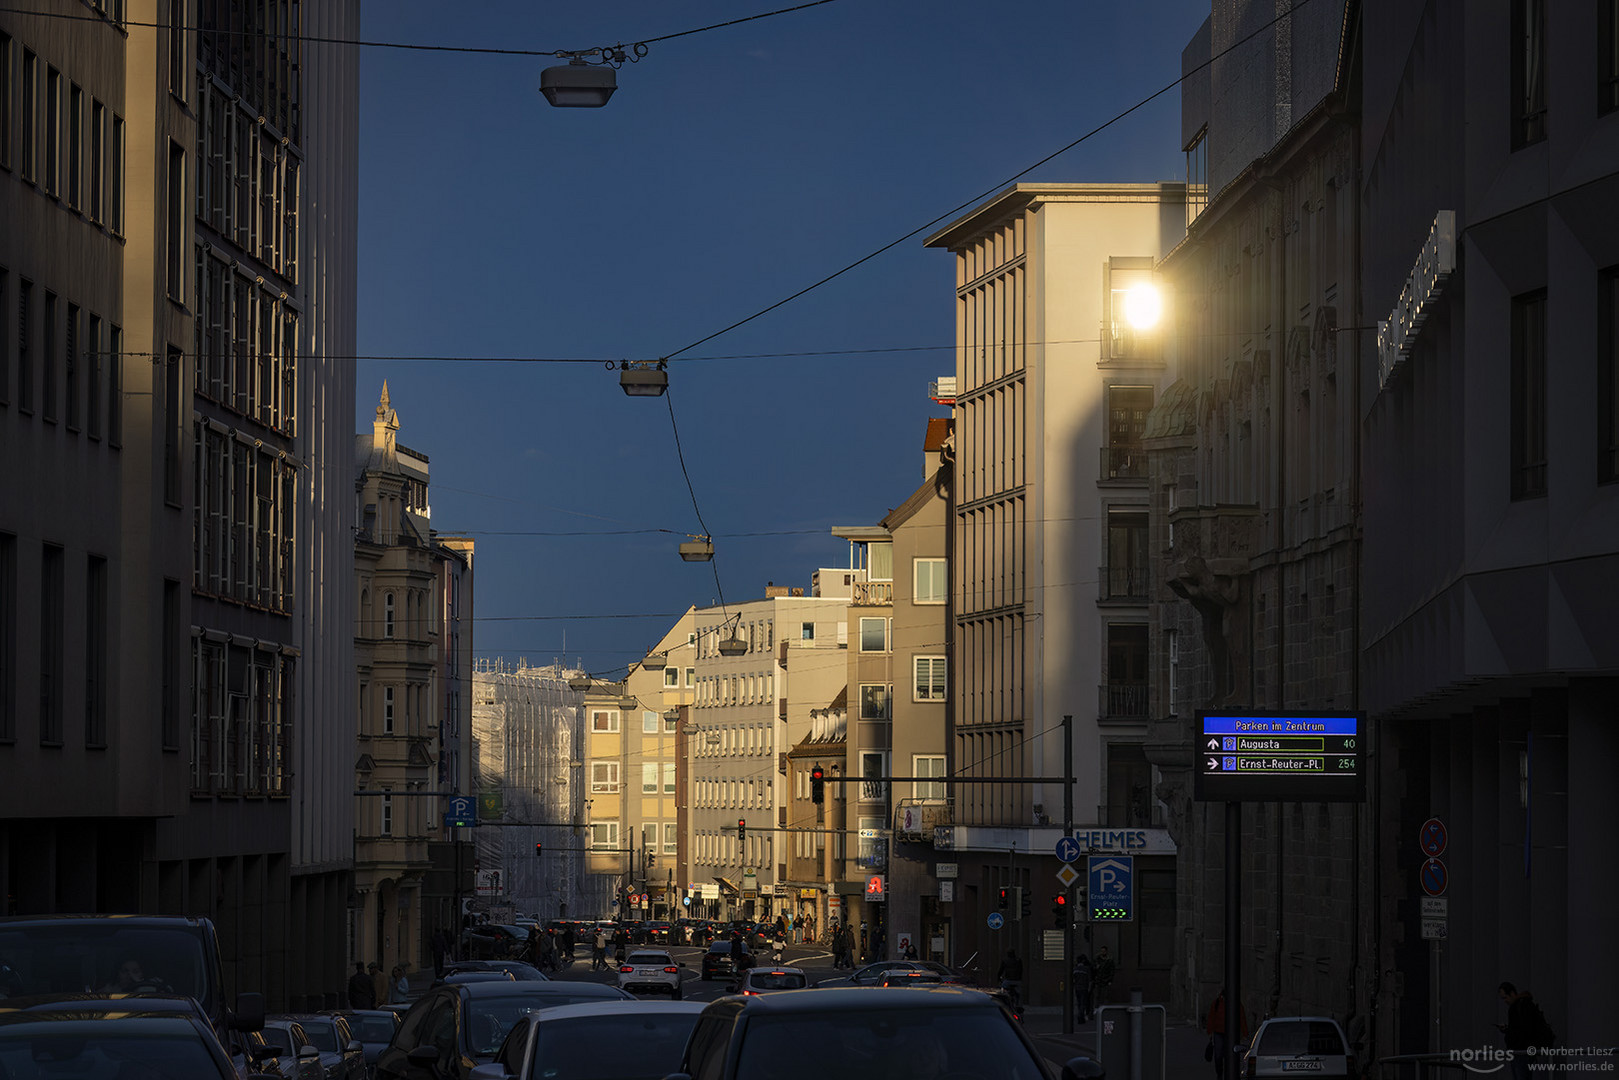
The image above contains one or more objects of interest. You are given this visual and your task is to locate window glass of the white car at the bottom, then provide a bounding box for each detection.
[528,1009,698,1080]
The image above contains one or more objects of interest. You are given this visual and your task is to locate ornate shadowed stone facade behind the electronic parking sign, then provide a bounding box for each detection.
[1143,3,1375,1036]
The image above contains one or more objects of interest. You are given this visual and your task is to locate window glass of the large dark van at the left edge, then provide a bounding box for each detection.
[0,920,214,1009]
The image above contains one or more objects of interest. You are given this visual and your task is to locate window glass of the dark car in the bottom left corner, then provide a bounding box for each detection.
[0,1020,223,1080]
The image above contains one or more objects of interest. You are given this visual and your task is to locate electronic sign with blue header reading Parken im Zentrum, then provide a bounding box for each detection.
[1193,711,1366,803]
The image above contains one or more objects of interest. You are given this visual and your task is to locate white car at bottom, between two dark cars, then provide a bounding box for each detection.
[473,1001,703,1080]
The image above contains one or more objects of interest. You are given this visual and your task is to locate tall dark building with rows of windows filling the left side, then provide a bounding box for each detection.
[0,0,358,1006]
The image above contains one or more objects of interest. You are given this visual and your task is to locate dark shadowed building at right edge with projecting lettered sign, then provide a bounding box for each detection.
[1358,0,1619,1067]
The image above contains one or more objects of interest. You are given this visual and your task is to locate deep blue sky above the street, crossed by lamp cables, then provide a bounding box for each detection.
[355,0,1208,677]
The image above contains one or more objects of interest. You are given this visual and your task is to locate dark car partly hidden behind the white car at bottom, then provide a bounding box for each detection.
[377,980,635,1080]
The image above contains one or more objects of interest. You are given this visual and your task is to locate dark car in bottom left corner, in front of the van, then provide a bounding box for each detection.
[0,999,268,1080]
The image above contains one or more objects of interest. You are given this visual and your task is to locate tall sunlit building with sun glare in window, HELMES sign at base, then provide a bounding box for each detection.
[926,183,1185,1004]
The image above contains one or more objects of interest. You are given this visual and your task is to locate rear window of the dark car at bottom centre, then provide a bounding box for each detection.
[737,1007,1044,1080]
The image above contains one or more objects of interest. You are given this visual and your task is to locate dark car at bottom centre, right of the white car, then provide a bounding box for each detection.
[667,986,1068,1080]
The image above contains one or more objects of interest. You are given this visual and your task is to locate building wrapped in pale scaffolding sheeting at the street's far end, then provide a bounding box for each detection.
[473,659,615,921]
